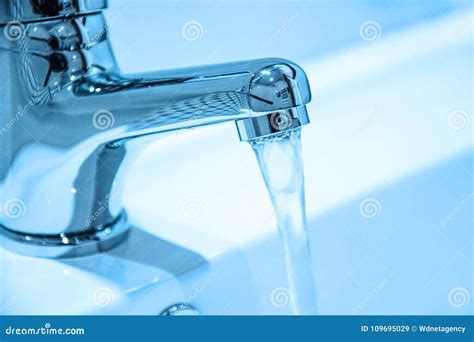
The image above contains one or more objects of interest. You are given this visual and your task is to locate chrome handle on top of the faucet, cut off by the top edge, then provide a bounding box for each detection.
[0,0,107,25]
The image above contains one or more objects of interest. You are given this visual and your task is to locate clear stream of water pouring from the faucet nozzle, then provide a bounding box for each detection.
[251,129,316,315]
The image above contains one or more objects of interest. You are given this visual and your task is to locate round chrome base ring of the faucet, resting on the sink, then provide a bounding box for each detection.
[0,211,130,258]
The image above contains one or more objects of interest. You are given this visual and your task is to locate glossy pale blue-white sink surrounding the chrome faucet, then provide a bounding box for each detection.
[0,1,474,315]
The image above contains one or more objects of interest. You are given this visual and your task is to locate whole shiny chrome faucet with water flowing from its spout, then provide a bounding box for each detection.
[0,0,311,258]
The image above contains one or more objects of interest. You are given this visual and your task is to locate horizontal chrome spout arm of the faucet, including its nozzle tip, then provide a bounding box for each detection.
[56,58,311,145]
